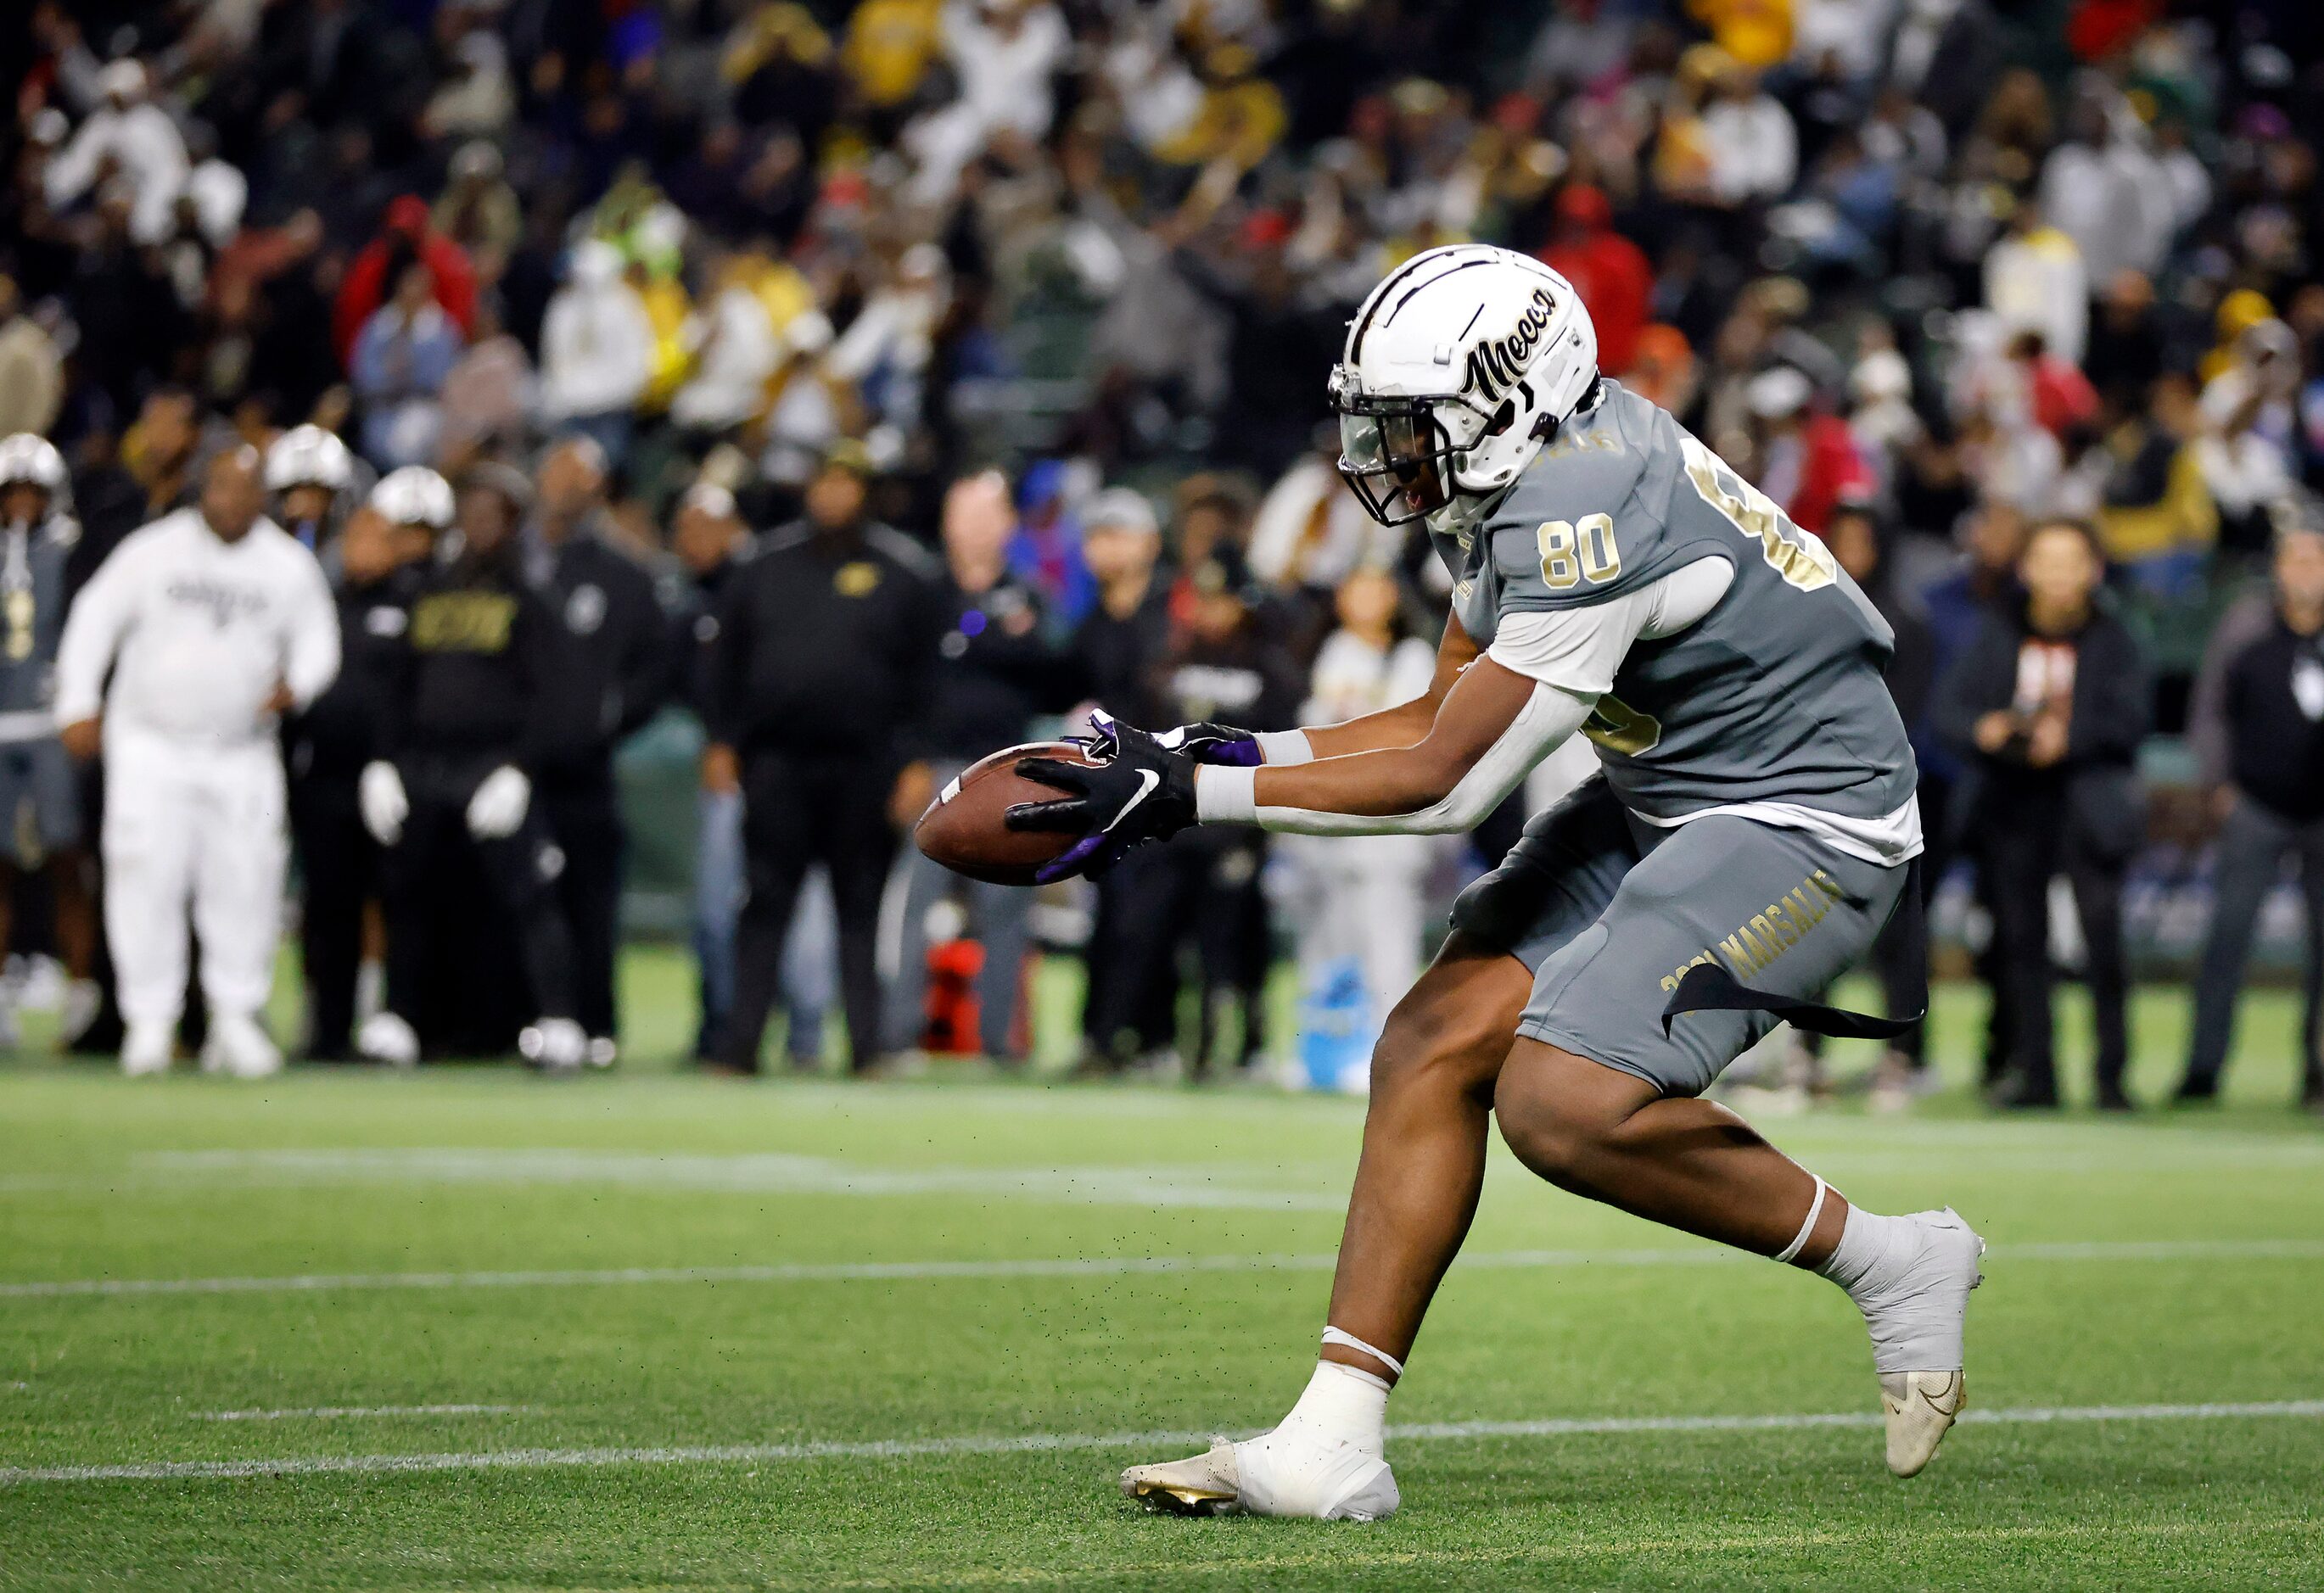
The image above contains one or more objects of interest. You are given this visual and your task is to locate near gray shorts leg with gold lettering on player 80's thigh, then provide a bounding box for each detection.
[1518,818,1908,1096]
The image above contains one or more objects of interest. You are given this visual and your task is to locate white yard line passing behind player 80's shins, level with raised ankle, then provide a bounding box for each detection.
[0,1240,2324,1300]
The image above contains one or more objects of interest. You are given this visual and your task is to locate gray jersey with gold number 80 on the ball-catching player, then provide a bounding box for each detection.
[1436,381,1919,819]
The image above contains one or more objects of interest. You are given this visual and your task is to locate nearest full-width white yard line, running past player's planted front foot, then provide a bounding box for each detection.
[0,1400,2324,1486]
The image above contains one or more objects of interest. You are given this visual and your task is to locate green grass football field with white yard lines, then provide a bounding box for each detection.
[0,954,2324,1589]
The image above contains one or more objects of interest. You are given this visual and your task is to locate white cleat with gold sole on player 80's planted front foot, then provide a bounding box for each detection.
[1123,1423,1403,1521]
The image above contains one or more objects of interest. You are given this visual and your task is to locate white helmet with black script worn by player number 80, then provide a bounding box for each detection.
[1331,243,1599,529]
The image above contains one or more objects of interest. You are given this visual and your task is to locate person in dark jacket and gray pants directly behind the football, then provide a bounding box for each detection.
[886,472,1064,1064]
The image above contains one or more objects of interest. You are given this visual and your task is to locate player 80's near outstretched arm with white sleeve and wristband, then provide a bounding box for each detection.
[1195,657,1594,836]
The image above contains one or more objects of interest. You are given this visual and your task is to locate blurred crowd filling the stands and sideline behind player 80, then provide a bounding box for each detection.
[0,0,2324,1105]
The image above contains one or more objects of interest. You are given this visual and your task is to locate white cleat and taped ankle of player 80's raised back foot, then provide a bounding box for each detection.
[1856,1205,1985,1477]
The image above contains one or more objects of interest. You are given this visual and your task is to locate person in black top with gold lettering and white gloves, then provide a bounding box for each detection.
[356,465,588,1070]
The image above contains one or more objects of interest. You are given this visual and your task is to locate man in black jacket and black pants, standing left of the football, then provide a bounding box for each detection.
[702,441,949,1073]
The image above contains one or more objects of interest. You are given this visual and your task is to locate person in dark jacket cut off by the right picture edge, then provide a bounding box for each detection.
[2177,497,2324,1112]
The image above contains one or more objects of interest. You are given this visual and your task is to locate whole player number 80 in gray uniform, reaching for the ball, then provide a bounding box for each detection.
[1009,243,1985,1518]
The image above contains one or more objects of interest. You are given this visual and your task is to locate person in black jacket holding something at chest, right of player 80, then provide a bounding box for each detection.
[1936,520,2152,1110]
